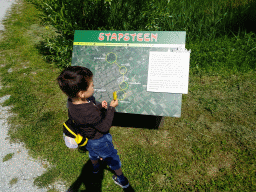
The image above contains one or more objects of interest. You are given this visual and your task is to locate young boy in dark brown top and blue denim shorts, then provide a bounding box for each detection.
[57,66,129,188]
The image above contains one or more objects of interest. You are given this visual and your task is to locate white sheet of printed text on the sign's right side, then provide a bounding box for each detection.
[147,51,190,94]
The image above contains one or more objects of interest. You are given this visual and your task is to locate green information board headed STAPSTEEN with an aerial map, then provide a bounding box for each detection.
[72,30,189,117]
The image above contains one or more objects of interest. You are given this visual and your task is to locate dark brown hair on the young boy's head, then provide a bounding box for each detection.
[57,66,93,98]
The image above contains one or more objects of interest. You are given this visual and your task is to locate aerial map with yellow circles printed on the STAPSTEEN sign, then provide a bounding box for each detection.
[72,45,182,117]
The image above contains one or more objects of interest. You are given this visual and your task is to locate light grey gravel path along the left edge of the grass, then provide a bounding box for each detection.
[0,0,68,192]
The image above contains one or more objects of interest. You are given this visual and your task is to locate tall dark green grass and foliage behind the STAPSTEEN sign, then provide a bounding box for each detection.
[26,0,256,69]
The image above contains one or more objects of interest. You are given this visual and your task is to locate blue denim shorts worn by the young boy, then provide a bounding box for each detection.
[86,133,122,170]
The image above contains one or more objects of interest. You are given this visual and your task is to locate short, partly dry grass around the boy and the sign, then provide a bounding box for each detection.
[0,1,256,191]
